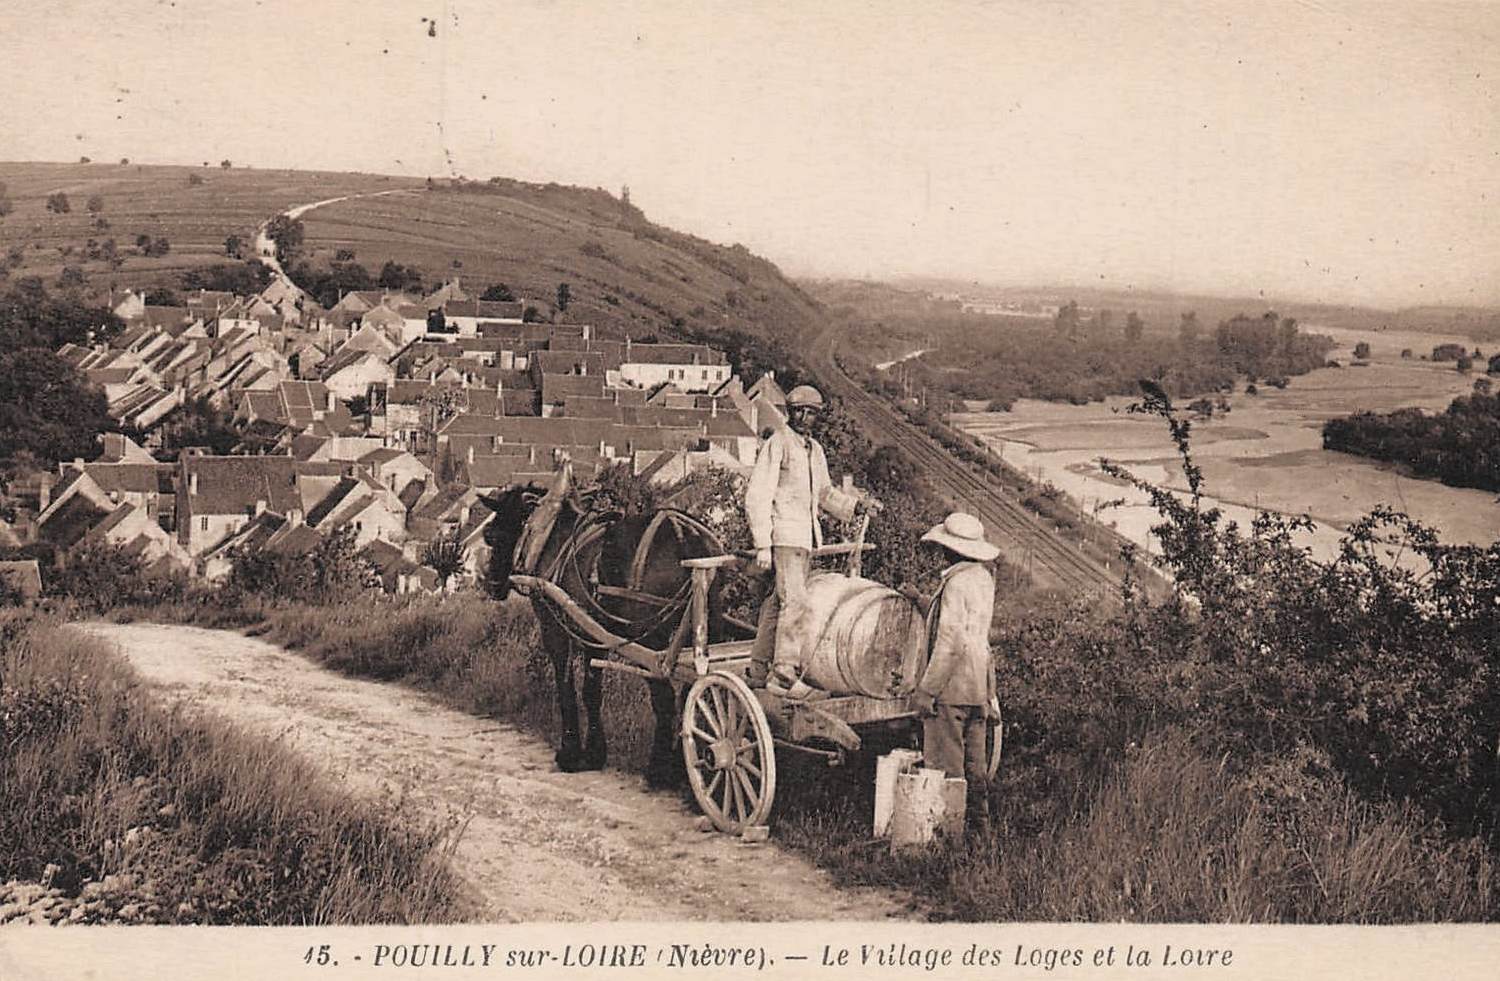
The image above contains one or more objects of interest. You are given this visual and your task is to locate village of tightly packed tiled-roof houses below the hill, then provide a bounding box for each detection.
[0,282,785,593]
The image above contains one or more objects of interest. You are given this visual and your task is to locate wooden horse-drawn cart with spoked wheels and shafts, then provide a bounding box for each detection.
[512,536,1001,834]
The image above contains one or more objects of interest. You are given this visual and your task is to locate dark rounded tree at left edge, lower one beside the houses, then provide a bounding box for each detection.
[0,348,111,461]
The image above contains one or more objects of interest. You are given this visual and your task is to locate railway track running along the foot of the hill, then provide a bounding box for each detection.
[824,338,1121,596]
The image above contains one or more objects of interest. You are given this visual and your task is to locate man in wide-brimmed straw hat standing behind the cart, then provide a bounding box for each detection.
[911,512,1001,827]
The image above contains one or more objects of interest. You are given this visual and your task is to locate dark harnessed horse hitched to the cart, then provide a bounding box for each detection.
[486,462,735,788]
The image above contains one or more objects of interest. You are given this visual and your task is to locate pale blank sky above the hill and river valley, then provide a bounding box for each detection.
[0,0,1500,306]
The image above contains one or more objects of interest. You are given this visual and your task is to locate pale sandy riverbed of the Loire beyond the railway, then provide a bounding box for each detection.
[956,329,1500,558]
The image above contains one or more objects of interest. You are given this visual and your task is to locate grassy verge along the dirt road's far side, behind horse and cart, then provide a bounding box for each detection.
[99,596,1500,923]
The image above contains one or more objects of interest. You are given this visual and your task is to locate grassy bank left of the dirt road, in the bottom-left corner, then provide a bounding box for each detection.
[0,614,462,926]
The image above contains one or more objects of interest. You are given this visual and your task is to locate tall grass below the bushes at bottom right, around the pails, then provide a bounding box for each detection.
[779,732,1497,924]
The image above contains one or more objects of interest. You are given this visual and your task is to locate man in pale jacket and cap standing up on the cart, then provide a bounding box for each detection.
[746,386,864,699]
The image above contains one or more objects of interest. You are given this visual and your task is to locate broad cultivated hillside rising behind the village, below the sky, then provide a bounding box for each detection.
[0,164,822,363]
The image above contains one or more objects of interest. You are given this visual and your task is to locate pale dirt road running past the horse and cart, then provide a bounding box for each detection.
[77,623,911,921]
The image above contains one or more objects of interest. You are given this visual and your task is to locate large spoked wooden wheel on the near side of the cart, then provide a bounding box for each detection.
[683,671,776,834]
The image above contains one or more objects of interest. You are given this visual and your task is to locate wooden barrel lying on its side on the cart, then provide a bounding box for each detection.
[803,573,927,698]
